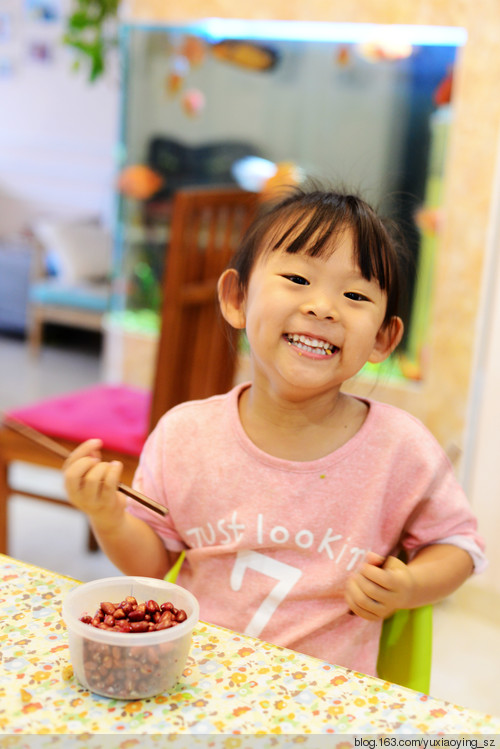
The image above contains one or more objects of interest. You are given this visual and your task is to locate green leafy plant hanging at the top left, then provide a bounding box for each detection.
[64,0,120,81]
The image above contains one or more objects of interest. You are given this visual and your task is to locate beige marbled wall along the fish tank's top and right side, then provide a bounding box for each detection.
[126,0,500,610]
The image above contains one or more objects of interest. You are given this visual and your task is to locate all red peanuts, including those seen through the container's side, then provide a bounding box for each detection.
[80,596,187,699]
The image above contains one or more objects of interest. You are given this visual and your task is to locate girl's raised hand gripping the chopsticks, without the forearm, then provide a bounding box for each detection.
[63,439,126,530]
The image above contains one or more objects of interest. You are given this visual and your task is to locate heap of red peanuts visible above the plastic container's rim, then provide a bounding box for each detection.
[80,596,187,632]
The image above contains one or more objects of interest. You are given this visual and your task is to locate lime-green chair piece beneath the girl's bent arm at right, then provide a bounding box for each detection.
[377,606,432,694]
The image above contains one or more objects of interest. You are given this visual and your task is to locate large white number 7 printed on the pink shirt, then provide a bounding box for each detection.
[231,551,302,637]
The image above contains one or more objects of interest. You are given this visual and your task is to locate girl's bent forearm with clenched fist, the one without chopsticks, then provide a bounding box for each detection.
[345,544,474,620]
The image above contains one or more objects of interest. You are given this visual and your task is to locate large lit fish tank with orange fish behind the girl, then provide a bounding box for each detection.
[112,19,466,380]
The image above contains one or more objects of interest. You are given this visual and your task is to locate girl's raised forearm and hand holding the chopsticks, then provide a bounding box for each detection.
[63,440,179,578]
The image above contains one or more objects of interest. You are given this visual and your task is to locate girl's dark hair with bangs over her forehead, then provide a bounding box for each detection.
[230,185,409,326]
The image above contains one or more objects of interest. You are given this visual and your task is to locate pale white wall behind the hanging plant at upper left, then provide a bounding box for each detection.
[0,0,119,228]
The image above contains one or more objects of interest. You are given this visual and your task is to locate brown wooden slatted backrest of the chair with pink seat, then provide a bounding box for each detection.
[150,187,257,429]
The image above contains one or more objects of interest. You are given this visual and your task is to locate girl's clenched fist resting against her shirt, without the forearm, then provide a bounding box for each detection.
[345,552,414,621]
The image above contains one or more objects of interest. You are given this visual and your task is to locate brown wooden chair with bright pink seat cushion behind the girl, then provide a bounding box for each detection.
[0,188,256,553]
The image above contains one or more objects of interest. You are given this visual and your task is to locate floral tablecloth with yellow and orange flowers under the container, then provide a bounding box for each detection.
[0,555,500,732]
